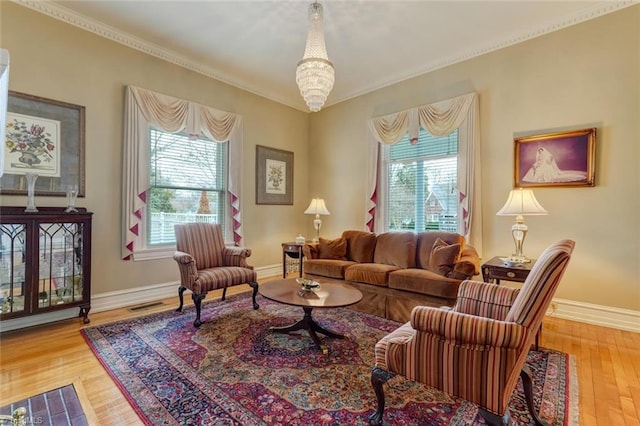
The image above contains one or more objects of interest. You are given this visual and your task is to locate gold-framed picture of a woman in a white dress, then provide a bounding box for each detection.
[514,128,596,188]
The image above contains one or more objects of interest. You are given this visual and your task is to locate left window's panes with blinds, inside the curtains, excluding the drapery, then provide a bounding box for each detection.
[145,128,228,248]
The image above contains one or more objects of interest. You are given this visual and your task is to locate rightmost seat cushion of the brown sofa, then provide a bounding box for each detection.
[389,268,460,299]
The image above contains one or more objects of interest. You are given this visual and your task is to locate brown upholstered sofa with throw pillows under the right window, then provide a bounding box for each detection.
[303,230,480,322]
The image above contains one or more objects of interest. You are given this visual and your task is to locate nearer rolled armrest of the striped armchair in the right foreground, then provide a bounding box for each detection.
[411,306,528,349]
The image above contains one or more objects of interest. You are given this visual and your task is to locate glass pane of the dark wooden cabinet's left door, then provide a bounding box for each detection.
[0,223,27,314]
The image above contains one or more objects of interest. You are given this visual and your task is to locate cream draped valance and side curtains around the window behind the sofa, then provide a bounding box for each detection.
[365,93,482,250]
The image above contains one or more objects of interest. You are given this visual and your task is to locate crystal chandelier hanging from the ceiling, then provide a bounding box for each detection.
[296,1,335,112]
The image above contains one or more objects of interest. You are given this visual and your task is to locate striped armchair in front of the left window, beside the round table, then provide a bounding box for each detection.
[173,223,259,327]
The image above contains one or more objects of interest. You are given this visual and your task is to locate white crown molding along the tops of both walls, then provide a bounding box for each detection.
[11,0,640,113]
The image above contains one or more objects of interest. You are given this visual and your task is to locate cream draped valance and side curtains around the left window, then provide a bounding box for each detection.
[122,86,243,259]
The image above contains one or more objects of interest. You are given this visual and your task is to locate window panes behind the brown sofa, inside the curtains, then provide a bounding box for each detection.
[383,128,458,232]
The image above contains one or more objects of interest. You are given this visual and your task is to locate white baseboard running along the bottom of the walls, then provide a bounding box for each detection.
[0,264,640,333]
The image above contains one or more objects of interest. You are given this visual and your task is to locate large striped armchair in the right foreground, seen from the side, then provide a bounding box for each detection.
[369,240,575,425]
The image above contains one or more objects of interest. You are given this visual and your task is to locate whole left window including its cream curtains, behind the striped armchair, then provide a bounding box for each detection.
[122,86,243,261]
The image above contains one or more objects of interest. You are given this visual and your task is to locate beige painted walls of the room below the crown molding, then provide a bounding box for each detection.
[0,2,640,311]
